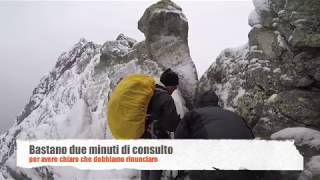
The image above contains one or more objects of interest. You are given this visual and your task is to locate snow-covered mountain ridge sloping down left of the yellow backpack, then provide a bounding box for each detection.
[0,33,189,179]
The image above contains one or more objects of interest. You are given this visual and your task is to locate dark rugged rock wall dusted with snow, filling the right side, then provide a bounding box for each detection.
[198,0,320,180]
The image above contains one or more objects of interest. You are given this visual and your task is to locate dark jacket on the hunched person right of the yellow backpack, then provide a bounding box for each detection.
[175,106,254,139]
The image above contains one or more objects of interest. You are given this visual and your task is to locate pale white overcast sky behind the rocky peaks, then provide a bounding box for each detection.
[0,0,254,133]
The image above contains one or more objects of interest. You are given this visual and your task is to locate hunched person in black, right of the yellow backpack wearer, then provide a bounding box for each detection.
[175,91,261,180]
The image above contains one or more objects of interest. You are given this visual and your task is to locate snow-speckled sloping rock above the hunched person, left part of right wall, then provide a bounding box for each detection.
[198,45,248,110]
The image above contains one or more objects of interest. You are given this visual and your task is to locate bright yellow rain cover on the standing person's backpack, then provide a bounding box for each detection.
[107,74,155,139]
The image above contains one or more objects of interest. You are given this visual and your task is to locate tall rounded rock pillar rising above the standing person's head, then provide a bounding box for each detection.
[138,0,198,107]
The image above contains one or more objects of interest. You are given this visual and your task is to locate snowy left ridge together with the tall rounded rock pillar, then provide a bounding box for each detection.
[0,1,197,179]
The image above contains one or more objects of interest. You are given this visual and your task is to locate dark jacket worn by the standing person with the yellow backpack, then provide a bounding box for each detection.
[143,84,180,139]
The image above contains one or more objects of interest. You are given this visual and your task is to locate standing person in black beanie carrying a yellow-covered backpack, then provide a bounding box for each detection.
[107,69,180,180]
